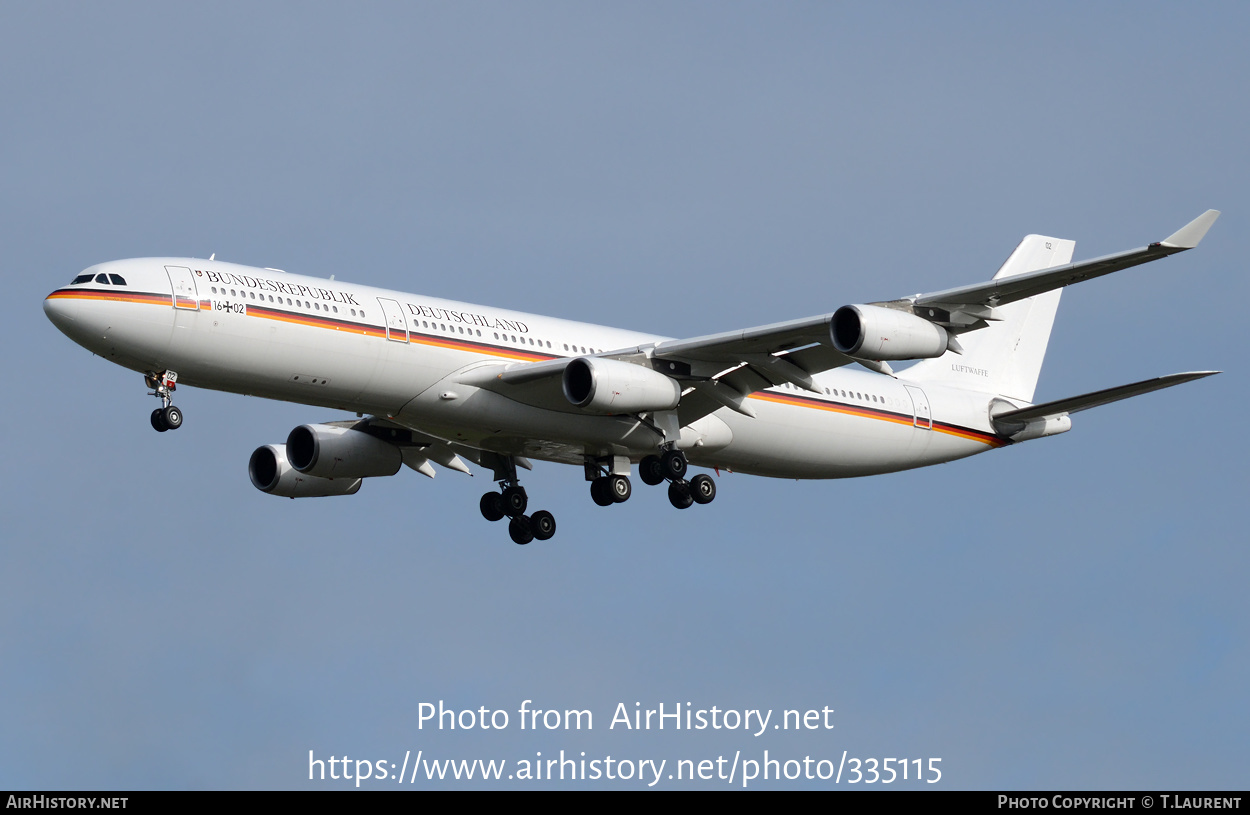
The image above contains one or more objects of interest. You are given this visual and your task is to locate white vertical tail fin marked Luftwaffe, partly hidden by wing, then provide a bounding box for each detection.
[899,235,1076,403]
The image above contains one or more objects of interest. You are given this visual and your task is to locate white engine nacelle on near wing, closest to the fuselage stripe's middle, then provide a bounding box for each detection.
[564,356,681,414]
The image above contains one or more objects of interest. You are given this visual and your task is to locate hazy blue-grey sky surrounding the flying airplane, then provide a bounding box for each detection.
[0,4,1250,789]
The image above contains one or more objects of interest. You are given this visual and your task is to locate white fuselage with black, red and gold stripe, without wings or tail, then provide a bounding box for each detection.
[44,258,1009,479]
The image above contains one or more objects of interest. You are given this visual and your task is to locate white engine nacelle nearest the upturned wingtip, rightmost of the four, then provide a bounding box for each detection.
[830,305,950,361]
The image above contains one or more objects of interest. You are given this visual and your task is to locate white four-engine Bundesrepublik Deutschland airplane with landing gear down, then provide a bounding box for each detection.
[44,210,1220,545]
